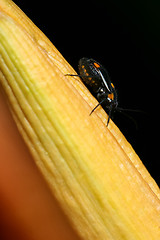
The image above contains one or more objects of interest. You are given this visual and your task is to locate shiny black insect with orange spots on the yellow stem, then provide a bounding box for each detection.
[66,57,118,126]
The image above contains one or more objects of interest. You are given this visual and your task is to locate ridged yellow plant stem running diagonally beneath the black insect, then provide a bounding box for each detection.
[0,0,160,240]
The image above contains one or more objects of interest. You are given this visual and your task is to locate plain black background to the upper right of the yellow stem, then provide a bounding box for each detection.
[14,0,160,185]
